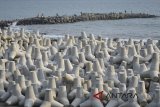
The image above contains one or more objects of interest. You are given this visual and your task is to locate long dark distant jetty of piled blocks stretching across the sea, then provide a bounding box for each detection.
[0,12,158,28]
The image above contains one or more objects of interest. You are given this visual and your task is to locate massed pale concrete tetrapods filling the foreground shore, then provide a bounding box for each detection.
[0,29,160,107]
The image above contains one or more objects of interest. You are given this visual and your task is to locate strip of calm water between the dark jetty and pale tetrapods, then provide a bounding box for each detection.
[21,18,160,39]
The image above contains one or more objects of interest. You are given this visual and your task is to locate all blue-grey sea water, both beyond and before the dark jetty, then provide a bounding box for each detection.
[0,0,160,40]
